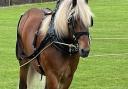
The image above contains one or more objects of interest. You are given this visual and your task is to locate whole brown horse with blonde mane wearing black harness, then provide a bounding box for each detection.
[16,0,93,89]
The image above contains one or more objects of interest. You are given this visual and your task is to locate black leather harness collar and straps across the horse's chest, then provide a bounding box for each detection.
[26,13,81,59]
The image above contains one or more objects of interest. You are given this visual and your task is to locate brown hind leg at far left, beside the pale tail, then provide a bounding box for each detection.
[19,62,28,89]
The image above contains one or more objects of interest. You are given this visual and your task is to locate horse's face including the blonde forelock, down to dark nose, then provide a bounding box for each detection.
[72,0,92,57]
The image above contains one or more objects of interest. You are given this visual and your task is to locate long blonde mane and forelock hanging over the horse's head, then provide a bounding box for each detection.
[54,0,93,37]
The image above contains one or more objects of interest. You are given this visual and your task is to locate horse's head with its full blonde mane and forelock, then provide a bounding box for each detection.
[55,0,92,57]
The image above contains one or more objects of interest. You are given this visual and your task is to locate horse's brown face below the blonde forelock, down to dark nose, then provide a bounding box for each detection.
[74,17,90,57]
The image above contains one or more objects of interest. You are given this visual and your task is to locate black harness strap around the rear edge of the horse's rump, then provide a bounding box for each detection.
[16,15,25,60]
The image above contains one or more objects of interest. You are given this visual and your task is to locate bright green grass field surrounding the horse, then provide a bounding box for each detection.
[0,0,128,89]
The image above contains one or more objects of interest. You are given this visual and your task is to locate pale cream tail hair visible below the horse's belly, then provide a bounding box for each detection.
[27,65,46,89]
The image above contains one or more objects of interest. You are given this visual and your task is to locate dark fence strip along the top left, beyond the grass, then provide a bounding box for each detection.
[0,0,55,6]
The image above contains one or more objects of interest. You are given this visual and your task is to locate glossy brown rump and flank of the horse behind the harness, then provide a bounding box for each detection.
[18,8,44,55]
